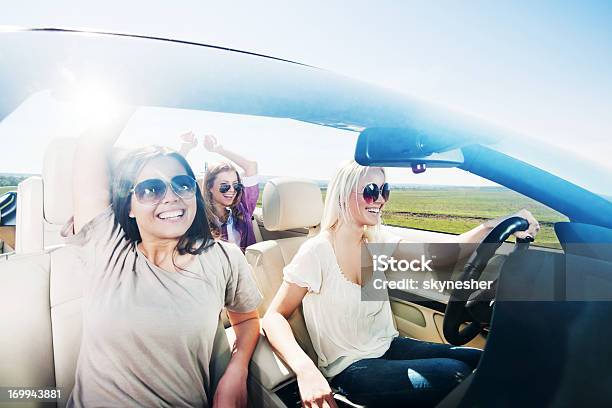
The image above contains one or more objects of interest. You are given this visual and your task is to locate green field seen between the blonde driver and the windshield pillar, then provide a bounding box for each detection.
[259,187,567,248]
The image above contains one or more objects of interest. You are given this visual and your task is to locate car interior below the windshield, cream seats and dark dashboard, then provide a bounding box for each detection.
[0,124,612,407]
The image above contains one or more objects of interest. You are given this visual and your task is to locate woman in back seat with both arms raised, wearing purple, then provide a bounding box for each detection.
[180,132,259,252]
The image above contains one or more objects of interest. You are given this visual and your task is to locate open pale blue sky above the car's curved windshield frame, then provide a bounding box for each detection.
[0,0,612,185]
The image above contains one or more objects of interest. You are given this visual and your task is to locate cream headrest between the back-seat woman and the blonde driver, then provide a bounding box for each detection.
[262,177,323,231]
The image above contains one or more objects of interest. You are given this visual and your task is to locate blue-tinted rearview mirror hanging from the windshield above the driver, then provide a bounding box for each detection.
[355,128,463,167]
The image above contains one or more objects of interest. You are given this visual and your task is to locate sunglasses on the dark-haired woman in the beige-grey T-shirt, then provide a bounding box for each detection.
[130,174,196,205]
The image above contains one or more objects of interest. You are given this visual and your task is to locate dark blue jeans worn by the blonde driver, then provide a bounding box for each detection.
[331,337,482,408]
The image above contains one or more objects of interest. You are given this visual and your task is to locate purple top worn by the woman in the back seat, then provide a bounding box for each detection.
[219,176,259,252]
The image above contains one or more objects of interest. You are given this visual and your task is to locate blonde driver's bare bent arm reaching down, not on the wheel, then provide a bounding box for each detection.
[263,282,336,407]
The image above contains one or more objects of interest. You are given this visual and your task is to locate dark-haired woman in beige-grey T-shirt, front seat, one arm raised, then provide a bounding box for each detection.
[65,110,261,407]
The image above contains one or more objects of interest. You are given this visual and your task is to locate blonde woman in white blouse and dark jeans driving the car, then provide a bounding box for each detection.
[263,162,538,408]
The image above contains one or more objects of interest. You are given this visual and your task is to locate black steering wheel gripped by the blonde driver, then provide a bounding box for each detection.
[443,217,533,346]
